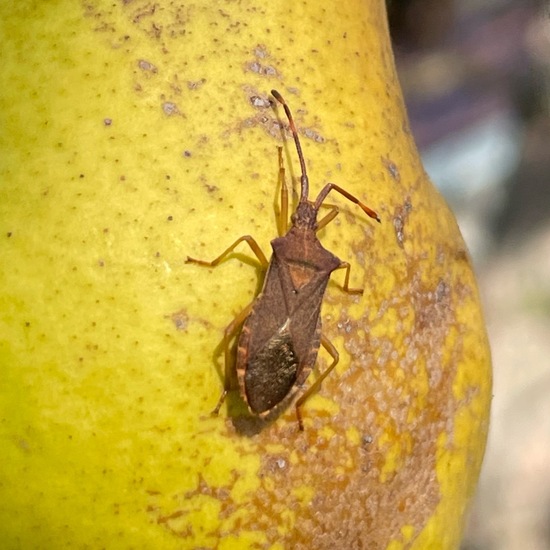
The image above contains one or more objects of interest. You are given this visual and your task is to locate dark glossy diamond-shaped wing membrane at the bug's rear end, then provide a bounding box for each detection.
[244,321,300,414]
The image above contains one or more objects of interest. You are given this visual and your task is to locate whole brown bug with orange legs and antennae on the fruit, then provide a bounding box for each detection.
[186,90,380,430]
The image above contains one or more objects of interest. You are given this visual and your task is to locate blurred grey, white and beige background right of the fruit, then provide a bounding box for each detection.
[387,0,550,550]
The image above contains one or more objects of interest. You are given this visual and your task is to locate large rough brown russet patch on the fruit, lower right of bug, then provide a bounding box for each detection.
[222,266,461,549]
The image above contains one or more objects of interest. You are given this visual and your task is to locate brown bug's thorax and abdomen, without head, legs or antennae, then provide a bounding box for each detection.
[237,227,341,415]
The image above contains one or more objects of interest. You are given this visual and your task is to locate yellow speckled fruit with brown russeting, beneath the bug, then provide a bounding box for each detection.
[0,0,491,550]
